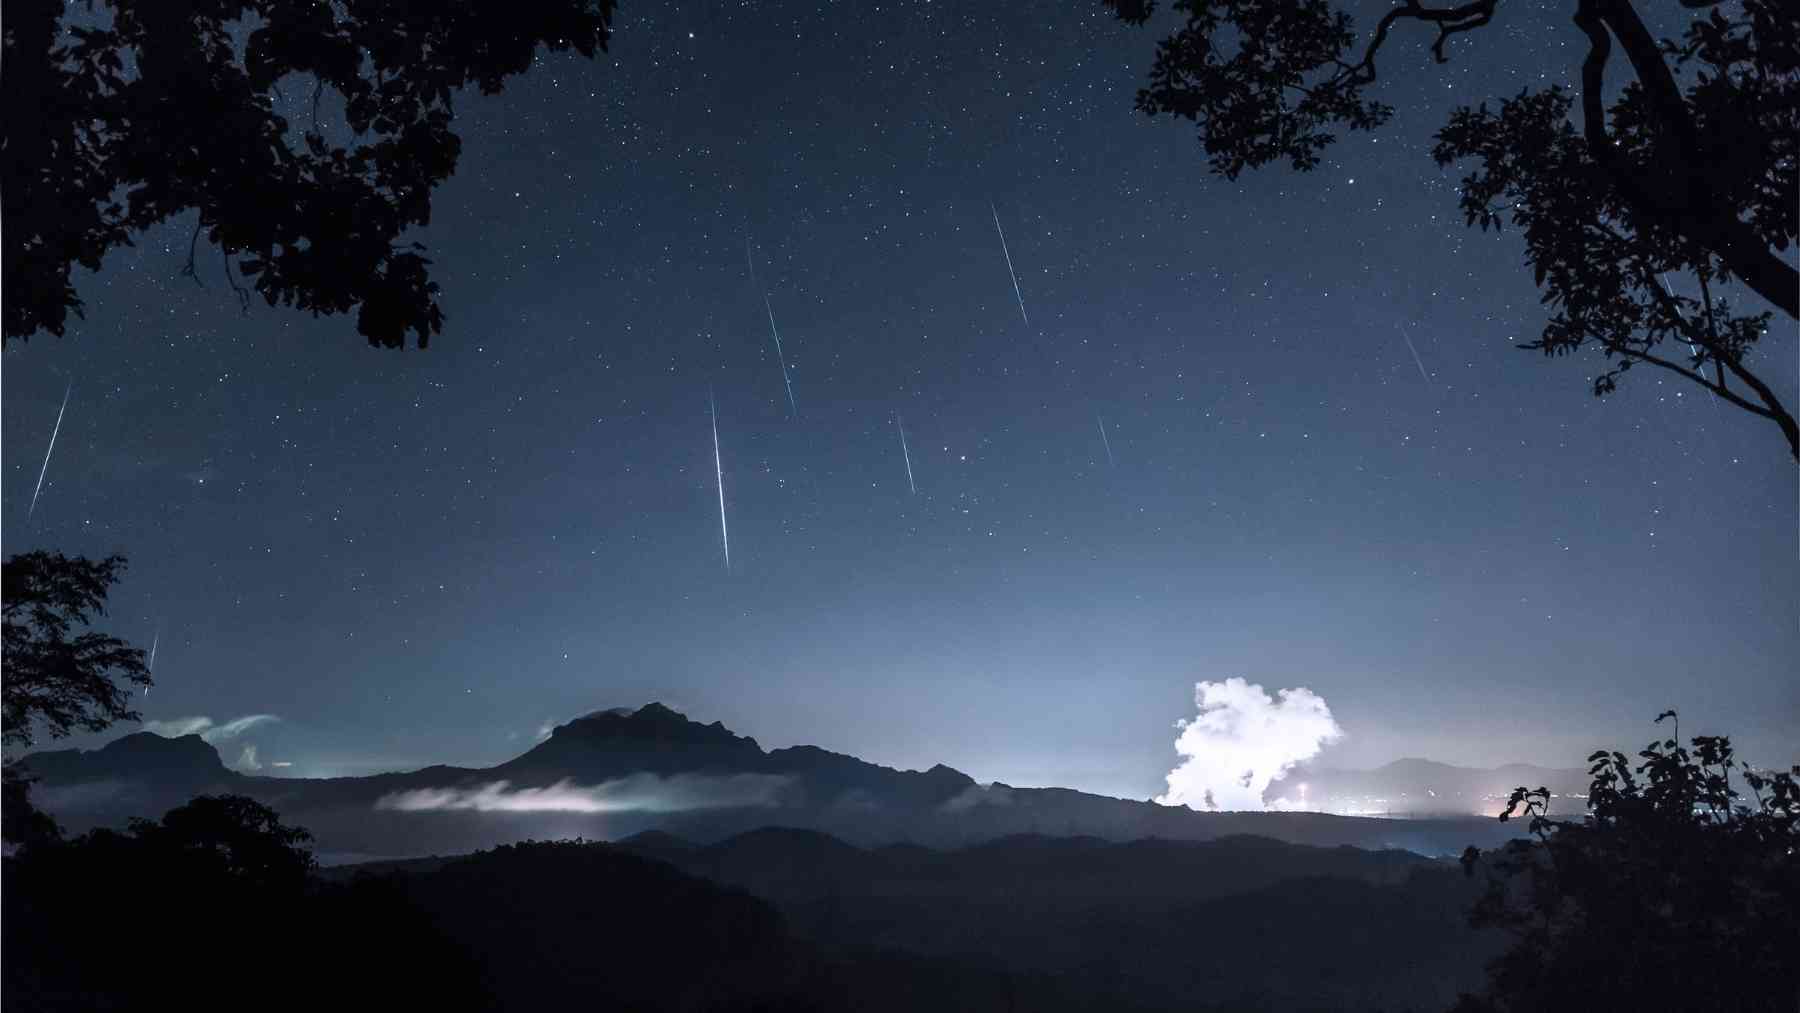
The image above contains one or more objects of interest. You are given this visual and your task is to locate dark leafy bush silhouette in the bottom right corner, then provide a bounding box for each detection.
[1456,711,1800,1013]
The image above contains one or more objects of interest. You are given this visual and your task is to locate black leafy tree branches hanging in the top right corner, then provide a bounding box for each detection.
[1105,0,1800,459]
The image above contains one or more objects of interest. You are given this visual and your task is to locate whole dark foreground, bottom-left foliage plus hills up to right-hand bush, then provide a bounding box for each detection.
[4,829,1490,1011]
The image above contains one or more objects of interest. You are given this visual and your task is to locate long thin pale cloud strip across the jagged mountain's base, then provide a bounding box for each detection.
[374,774,790,813]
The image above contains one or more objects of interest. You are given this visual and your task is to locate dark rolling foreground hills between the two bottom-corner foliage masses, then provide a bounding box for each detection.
[331,828,1496,1013]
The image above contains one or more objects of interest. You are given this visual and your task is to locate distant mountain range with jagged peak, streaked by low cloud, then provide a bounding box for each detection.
[22,704,1571,862]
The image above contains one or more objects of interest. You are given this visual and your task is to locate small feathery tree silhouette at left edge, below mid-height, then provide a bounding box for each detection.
[0,552,151,844]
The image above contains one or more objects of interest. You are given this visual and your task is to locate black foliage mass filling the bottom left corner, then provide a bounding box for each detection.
[0,797,491,1013]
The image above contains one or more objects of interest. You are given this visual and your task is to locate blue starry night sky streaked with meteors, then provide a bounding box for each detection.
[4,0,1800,797]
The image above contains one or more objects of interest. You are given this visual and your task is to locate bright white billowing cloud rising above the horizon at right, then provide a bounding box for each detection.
[1157,678,1345,810]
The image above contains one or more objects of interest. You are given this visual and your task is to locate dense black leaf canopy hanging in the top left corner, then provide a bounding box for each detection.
[0,0,614,347]
